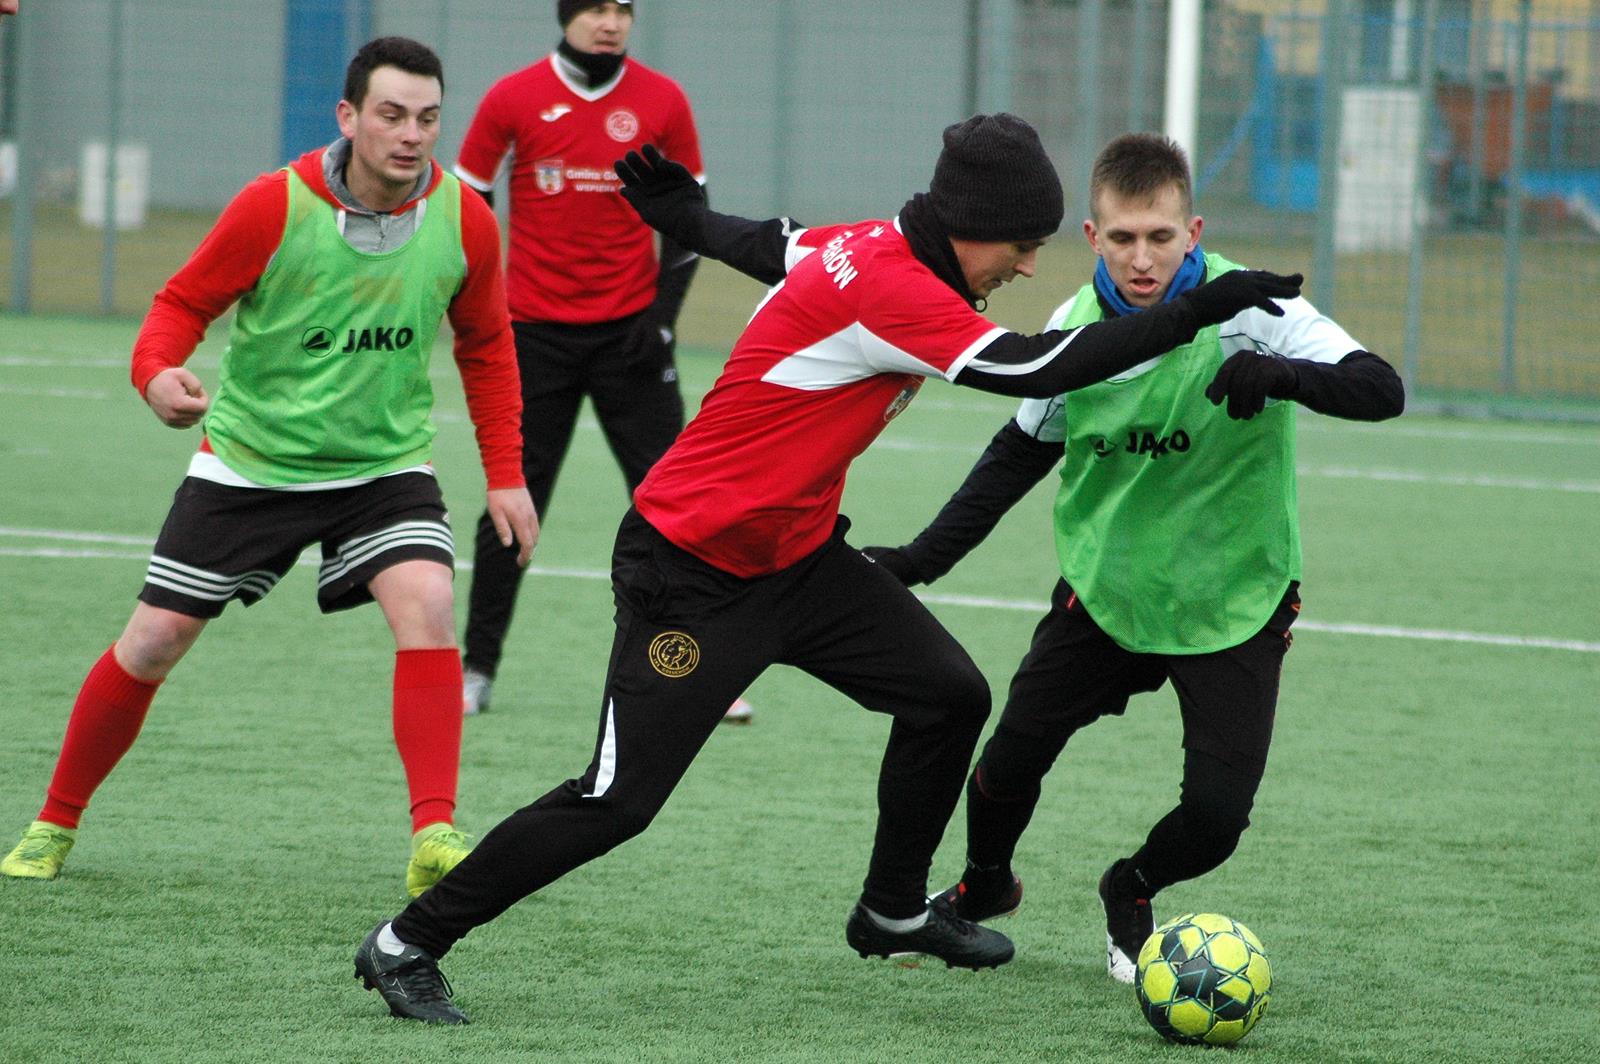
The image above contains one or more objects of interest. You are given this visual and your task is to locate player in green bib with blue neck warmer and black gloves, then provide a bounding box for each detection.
[866,134,1405,982]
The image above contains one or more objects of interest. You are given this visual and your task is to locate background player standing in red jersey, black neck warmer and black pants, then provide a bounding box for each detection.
[456,0,750,722]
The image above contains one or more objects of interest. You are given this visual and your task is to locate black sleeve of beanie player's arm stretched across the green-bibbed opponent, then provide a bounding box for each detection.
[955,299,1200,398]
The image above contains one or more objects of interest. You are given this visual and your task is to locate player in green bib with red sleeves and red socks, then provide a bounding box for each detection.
[0,37,539,894]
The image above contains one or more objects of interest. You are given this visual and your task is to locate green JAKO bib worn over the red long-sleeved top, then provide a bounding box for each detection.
[205,170,466,485]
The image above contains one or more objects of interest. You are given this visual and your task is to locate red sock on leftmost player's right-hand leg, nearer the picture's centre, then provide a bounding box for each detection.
[394,646,461,832]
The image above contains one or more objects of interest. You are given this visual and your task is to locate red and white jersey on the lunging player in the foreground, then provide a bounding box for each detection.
[634,221,1005,578]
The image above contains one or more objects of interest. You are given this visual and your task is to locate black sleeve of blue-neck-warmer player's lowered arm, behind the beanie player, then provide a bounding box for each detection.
[901,421,1064,584]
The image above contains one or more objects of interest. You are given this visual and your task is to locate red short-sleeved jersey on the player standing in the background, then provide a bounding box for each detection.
[456,54,704,325]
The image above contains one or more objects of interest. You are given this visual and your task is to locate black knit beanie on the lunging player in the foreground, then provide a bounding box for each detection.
[928,112,1067,240]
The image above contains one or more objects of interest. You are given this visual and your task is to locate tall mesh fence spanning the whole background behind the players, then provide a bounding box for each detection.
[0,0,1600,418]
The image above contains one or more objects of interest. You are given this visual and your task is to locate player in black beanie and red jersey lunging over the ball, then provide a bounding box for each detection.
[355,114,1299,1022]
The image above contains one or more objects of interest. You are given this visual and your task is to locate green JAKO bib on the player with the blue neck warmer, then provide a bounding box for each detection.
[1051,254,1301,654]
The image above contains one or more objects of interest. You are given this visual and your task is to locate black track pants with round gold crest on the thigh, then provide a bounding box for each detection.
[395,510,989,957]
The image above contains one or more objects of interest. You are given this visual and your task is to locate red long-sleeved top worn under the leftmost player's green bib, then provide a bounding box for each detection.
[133,149,523,490]
